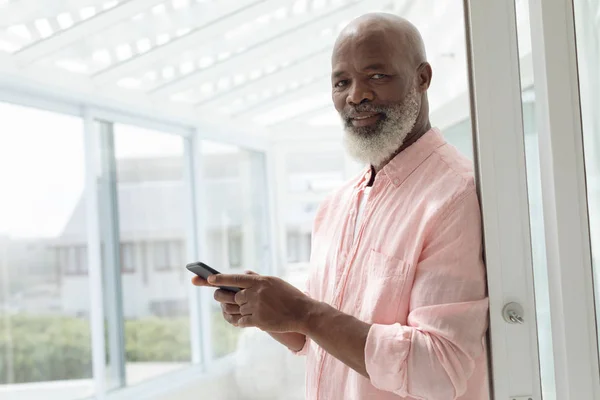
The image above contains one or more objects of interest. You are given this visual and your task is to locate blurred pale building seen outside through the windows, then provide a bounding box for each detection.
[0,154,324,319]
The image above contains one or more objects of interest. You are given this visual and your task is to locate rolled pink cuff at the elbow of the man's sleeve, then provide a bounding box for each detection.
[365,324,413,395]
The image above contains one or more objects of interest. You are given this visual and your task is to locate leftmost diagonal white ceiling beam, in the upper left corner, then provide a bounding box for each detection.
[14,0,164,65]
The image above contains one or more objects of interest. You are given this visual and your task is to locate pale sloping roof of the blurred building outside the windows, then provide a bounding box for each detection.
[58,157,315,242]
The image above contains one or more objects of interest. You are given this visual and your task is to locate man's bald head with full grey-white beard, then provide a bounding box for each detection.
[331,13,432,167]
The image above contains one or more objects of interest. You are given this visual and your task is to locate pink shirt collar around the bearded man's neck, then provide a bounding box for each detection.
[356,128,446,187]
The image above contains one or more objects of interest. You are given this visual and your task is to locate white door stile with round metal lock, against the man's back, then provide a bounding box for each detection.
[464,0,541,400]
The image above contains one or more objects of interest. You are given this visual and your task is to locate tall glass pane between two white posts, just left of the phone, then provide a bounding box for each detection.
[114,124,191,385]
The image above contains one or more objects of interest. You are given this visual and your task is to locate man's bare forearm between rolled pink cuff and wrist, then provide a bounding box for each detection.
[302,301,371,378]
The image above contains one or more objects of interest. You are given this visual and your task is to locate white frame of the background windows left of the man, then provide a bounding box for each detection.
[0,80,272,400]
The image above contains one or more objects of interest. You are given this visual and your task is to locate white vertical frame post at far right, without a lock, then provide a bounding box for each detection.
[529,0,600,400]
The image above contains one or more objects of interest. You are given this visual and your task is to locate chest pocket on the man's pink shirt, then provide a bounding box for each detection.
[359,250,410,324]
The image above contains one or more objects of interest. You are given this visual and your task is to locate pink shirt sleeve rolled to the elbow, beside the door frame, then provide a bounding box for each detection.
[365,189,488,400]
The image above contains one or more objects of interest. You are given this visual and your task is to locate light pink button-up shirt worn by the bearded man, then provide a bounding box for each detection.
[299,129,489,400]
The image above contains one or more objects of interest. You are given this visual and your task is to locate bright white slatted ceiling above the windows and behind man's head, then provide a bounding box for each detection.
[0,0,492,133]
